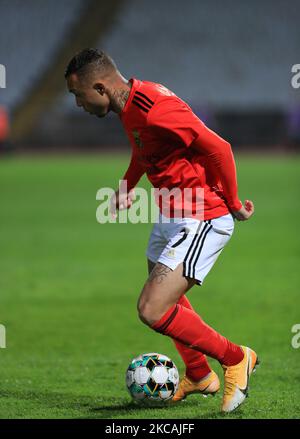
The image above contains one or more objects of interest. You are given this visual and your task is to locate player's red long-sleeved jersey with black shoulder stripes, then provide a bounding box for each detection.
[120,78,242,219]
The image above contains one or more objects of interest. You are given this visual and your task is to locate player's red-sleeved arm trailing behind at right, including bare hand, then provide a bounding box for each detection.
[190,124,254,221]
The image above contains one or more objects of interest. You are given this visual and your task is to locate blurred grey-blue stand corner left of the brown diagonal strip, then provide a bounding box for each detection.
[0,0,84,111]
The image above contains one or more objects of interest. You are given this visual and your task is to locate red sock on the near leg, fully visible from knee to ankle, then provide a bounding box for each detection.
[152,304,244,366]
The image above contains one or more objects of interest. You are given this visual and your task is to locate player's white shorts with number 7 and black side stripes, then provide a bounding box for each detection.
[147,213,234,285]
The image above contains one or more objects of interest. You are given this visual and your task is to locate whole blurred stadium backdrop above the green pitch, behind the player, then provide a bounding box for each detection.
[0,0,300,151]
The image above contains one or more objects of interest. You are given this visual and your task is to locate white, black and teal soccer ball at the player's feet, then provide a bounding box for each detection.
[126,353,179,405]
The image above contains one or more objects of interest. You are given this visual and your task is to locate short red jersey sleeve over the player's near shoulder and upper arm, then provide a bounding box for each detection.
[147,96,203,147]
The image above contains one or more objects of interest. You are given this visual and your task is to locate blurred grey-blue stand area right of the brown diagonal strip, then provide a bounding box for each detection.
[62,0,300,109]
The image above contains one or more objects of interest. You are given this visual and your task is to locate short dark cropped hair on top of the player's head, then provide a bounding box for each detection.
[65,48,117,79]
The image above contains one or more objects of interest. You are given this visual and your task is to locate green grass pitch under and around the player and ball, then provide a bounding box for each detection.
[0,155,300,419]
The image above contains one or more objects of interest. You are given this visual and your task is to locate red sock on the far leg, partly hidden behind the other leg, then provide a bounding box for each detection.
[173,295,211,382]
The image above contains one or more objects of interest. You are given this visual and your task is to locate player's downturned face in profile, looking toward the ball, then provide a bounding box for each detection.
[67,74,111,117]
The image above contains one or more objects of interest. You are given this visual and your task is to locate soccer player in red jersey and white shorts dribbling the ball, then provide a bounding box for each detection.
[65,49,258,412]
